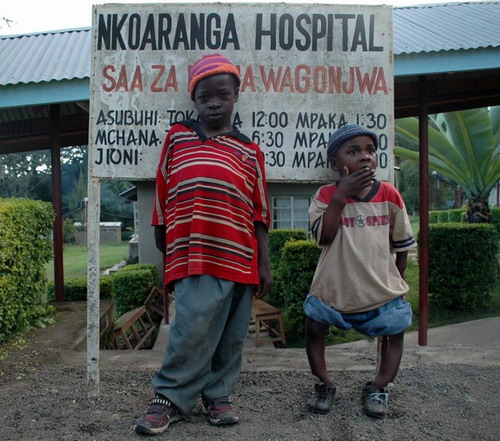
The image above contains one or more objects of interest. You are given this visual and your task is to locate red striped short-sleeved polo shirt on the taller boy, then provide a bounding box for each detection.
[152,120,270,284]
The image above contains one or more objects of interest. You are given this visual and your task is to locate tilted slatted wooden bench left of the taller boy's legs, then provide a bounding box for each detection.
[113,306,155,349]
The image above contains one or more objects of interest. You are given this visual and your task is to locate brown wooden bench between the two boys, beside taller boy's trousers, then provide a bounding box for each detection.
[248,299,286,347]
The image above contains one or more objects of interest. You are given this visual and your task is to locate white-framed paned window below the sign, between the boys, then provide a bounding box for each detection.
[272,196,311,232]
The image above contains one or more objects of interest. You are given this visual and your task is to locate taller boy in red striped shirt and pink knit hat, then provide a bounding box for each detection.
[136,54,272,434]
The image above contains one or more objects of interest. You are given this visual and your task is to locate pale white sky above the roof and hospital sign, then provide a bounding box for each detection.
[0,0,479,35]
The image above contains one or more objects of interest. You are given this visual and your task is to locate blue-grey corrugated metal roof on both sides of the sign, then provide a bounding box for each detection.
[0,0,500,86]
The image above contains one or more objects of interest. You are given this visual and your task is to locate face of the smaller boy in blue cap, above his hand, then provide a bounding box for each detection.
[332,135,377,175]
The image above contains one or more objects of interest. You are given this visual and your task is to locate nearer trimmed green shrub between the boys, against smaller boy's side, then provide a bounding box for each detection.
[276,240,321,343]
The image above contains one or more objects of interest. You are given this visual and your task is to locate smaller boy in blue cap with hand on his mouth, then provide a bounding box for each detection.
[304,125,416,418]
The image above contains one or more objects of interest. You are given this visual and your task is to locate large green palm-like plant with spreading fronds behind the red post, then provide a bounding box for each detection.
[394,106,500,222]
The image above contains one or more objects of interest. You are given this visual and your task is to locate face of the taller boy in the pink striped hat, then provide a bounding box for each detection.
[194,74,238,131]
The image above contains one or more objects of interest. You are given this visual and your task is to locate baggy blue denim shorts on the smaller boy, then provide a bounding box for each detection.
[304,294,412,337]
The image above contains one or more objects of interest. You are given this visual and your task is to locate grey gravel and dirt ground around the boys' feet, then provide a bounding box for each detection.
[0,306,500,441]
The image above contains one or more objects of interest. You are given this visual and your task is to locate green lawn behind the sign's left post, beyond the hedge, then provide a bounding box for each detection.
[45,241,128,280]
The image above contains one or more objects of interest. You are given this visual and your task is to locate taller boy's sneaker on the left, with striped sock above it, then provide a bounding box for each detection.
[135,395,184,435]
